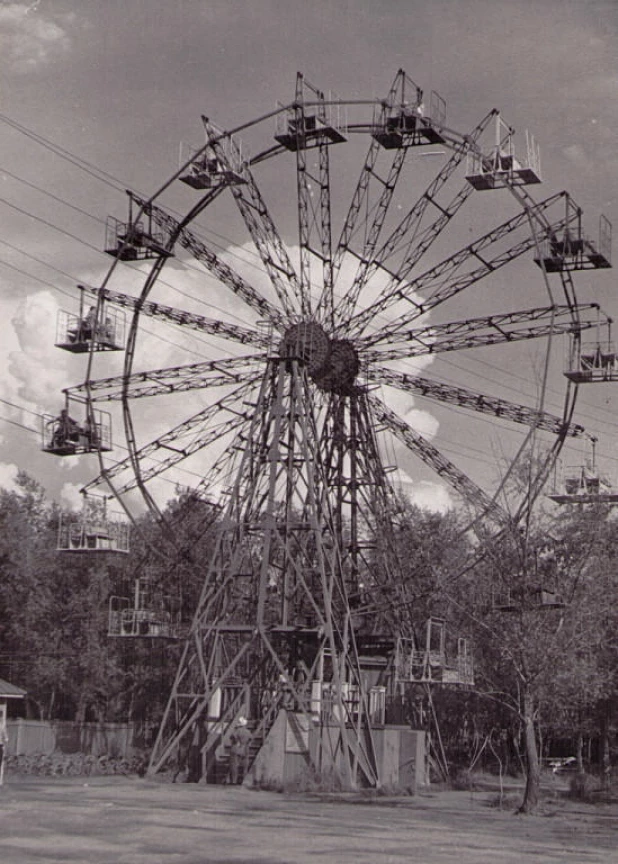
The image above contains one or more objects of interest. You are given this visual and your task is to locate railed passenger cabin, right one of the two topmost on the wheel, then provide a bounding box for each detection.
[371,71,446,150]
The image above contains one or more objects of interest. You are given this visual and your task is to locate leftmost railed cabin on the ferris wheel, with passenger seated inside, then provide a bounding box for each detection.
[41,402,112,456]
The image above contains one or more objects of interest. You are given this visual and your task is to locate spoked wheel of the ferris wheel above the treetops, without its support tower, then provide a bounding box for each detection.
[60,70,609,536]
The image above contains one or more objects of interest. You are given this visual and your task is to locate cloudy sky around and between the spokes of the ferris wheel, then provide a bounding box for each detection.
[0,0,618,506]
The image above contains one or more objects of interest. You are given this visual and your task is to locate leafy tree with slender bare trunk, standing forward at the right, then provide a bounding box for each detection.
[452,496,608,813]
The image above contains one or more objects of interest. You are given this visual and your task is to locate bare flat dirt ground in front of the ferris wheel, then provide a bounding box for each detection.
[0,776,618,864]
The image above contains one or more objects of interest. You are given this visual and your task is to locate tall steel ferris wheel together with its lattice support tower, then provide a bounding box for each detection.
[54,70,611,775]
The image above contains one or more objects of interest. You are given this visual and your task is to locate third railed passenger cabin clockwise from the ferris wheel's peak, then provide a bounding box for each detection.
[534,201,612,273]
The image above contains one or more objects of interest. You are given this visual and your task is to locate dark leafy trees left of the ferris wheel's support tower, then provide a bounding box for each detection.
[0,472,214,722]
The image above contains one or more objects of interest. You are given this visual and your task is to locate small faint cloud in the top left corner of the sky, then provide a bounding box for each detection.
[0,3,70,73]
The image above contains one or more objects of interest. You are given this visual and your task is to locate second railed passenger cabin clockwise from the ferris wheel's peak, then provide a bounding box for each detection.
[466,113,541,191]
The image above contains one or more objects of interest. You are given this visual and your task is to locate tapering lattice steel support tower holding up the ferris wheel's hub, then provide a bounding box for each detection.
[151,334,398,786]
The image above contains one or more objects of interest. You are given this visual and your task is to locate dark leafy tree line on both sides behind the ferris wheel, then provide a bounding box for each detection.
[0,472,618,809]
